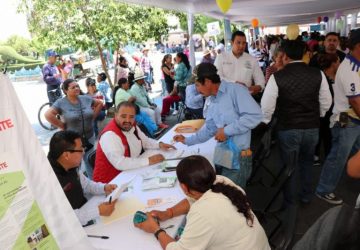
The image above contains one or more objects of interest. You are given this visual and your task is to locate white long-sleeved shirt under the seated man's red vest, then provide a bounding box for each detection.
[99,127,159,171]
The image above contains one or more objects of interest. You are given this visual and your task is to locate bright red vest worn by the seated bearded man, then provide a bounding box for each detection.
[93,119,139,183]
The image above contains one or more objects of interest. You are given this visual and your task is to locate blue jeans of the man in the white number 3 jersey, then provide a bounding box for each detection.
[316,122,360,195]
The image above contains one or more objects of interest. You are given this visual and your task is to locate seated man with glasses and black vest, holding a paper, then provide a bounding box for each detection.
[48,130,116,225]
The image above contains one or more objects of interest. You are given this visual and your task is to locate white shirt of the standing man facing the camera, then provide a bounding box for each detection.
[214,51,265,89]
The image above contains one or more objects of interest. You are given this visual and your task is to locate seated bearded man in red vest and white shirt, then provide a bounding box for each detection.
[93,102,175,183]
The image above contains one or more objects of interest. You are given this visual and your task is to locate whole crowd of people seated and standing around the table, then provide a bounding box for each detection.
[39,26,360,249]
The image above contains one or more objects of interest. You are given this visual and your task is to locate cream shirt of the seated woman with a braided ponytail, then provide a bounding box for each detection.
[166,175,270,250]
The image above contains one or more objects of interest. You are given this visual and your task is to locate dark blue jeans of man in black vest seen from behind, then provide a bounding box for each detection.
[278,128,319,204]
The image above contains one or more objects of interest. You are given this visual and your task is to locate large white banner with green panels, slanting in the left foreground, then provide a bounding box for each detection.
[0,73,93,250]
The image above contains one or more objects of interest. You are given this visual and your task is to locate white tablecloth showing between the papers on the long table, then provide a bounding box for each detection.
[85,129,216,250]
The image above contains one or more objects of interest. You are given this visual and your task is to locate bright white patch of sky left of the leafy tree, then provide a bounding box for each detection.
[0,0,30,41]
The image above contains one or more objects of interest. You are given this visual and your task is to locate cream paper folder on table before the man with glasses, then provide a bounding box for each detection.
[100,196,145,225]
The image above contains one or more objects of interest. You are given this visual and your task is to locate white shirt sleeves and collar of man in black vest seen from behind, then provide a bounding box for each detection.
[261,61,332,124]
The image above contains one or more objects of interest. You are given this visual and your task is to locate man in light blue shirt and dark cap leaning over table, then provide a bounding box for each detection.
[174,63,262,186]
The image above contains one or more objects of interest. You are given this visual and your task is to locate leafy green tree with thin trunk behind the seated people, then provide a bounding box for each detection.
[20,0,168,86]
